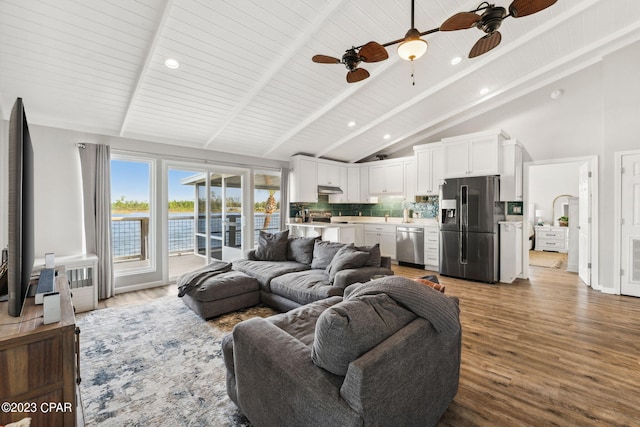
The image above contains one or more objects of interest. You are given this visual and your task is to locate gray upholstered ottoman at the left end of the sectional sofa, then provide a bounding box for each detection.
[182,271,260,319]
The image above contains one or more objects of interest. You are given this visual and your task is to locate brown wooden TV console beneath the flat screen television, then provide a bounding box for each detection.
[0,268,83,426]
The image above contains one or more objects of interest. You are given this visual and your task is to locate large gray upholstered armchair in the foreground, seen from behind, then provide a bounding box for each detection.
[222,276,462,427]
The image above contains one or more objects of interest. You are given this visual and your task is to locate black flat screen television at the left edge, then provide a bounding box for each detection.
[1,98,35,317]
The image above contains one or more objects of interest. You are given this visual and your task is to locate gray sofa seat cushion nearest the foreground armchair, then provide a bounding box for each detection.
[270,270,344,305]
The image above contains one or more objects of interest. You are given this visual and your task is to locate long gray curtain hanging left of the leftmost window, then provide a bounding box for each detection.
[78,144,115,300]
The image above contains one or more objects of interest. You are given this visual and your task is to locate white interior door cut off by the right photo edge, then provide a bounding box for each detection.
[620,154,640,297]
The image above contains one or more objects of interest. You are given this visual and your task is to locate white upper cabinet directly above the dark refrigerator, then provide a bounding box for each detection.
[442,131,508,178]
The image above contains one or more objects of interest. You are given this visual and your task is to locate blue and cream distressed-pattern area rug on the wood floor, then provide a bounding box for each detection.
[77,296,275,426]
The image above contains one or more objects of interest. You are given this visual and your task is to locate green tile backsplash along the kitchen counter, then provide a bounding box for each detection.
[289,195,439,218]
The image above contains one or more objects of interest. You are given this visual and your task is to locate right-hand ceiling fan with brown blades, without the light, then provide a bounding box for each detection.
[440,0,557,58]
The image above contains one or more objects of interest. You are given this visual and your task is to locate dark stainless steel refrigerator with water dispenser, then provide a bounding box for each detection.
[440,176,504,283]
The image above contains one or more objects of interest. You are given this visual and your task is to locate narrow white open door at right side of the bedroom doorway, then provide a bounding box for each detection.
[578,162,591,286]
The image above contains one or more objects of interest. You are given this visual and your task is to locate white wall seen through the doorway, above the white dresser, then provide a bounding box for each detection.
[529,162,584,224]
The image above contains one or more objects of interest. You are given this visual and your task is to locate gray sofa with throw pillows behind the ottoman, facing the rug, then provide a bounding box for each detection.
[232,236,393,311]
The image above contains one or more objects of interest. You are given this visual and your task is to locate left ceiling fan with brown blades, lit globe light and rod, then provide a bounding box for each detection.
[312,0,438,83]
